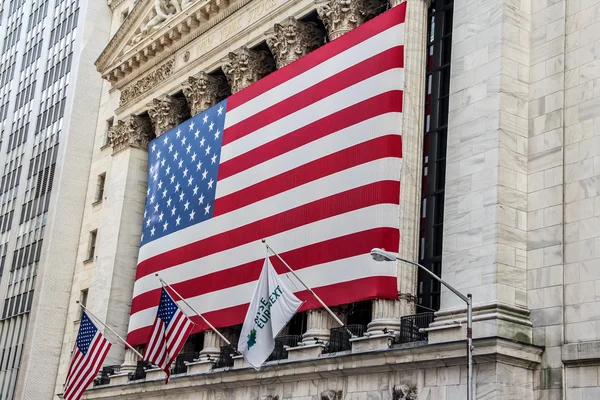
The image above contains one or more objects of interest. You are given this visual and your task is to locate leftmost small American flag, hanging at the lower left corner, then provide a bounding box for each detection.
[63,312,111,400]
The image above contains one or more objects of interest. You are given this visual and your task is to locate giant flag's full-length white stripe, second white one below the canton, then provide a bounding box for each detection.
[133,204,397,300]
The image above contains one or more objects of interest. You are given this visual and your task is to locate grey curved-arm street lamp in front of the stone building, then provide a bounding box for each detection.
[371,249,473,400]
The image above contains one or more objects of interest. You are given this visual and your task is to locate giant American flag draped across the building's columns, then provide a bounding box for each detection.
[128,5,405,344]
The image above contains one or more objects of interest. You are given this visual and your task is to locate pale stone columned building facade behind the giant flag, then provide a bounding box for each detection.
[39,0,600,400]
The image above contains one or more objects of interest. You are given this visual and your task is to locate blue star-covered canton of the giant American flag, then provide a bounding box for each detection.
[141,100,227,246]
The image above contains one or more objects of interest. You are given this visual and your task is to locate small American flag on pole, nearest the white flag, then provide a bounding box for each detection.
[144,288,193,383]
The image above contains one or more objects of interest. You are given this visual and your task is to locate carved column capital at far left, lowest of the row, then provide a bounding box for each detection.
[108,114,154,155]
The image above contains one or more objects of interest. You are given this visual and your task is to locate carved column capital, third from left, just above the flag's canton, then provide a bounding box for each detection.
[183,72,229,115]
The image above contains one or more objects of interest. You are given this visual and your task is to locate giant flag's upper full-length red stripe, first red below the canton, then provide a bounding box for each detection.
[136,181,400,278]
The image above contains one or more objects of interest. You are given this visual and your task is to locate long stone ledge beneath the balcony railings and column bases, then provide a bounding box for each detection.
[79,338,544,399]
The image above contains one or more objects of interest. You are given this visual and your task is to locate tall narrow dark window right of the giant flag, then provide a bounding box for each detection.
[417,0,453,312]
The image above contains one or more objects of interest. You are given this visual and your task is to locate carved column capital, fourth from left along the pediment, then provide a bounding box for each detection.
[221,46,275,94]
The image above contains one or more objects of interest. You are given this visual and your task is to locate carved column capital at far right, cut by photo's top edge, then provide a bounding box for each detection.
[316,0,380,40]
